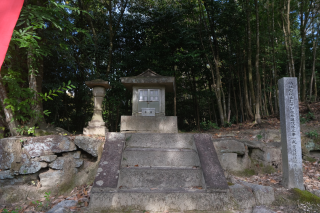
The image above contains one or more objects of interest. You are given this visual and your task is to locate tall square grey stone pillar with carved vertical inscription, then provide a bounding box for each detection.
[278,77,305,190]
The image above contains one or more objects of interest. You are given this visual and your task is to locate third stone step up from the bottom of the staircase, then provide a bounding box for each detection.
[121,148,200,168]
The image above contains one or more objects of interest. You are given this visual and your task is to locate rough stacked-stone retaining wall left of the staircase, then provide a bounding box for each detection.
[0,135,105,203]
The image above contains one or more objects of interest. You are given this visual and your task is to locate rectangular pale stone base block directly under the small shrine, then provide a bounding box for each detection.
[120,116,178,133]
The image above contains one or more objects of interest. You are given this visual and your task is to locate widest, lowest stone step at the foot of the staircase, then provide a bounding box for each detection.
[89,192,229,212]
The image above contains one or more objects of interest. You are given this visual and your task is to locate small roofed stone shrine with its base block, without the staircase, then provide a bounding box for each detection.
[120,69,178,133]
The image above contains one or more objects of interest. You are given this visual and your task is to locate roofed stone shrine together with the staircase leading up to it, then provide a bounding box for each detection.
[89,70,230,212]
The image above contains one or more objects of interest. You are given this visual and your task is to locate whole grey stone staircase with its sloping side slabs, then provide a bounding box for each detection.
[89,133,230,212]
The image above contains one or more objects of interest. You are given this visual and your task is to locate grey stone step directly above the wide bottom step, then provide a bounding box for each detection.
[118,168,202,189]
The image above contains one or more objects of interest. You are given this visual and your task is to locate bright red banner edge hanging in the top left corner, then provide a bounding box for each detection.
[0,0,24,70]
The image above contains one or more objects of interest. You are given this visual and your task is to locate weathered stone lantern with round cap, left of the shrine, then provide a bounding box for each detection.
[83,79,111,136]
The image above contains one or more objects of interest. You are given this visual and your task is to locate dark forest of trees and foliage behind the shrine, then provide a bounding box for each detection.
[0,0,320,136]
